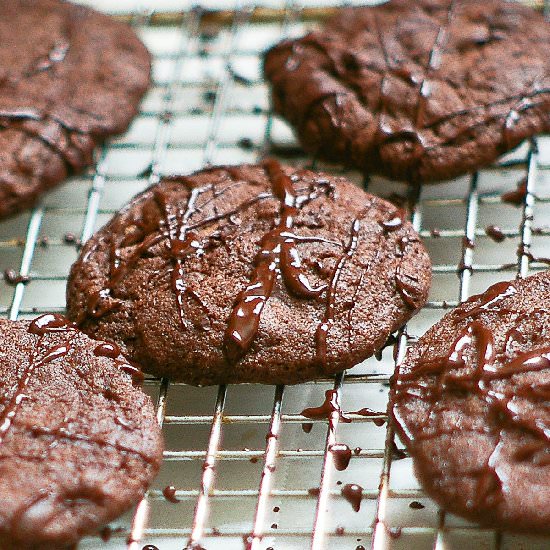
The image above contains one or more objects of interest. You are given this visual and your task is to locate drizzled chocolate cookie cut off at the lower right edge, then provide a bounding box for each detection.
[391,272,550,532]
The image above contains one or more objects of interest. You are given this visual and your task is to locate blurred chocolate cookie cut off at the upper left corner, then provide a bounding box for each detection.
[0,0,150,218]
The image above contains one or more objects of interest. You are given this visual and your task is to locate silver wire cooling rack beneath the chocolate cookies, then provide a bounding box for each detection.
[0,0,550,550]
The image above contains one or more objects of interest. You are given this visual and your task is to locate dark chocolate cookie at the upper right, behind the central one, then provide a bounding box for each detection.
[264,0,550,182]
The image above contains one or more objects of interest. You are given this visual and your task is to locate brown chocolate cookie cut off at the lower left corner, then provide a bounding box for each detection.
[0,314,163,550]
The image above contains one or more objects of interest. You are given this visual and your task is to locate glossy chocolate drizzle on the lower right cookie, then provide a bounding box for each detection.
[396,282,550,507]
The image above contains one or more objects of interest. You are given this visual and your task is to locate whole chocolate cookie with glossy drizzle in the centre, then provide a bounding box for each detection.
[67,160,430,385]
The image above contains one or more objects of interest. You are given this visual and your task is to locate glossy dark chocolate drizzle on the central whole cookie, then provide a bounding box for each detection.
[87,160,384,365]
